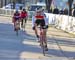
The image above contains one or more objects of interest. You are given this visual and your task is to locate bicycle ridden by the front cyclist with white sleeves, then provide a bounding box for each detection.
[39,26,46,56]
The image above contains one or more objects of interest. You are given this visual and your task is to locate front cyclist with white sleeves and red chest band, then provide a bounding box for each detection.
[32,9,48,50]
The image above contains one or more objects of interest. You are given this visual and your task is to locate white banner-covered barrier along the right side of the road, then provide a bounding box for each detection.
[46,13,75,34]
